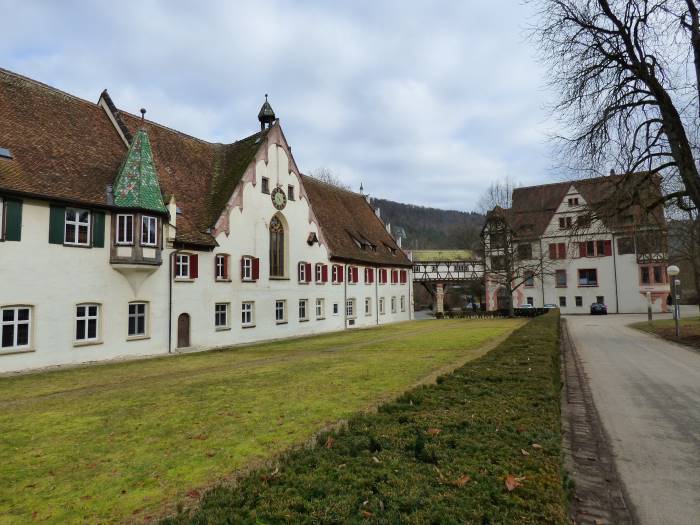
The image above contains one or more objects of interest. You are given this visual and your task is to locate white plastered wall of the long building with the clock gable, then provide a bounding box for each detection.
[0,137,412,372]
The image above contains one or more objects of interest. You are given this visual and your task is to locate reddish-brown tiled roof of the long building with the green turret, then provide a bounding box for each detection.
[0,69,411,266]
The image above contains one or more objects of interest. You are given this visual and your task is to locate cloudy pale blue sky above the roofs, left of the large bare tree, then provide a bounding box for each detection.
[0,0,556,211]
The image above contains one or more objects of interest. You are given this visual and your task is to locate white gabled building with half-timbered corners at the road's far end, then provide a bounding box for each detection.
[483,174,669,314]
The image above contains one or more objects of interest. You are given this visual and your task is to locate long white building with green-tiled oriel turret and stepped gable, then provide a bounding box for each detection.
[0,69,412,372]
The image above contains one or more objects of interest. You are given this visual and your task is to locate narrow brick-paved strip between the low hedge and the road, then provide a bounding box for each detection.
[560,319,639,525]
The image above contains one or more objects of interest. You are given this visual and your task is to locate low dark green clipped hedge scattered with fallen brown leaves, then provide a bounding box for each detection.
[163,312,567,525]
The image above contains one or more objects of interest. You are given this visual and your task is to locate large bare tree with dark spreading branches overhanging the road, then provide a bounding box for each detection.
[531,0,700,213]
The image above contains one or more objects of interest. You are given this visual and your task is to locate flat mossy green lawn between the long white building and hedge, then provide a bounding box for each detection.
[0,320,523,523]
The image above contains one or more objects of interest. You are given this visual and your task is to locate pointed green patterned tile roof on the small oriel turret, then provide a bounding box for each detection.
[114,129,167,213]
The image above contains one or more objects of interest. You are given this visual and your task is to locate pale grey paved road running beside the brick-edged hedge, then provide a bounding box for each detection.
[566,315,700,525]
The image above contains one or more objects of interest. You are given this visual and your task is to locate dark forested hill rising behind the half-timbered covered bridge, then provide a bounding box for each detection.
[372,199,484,250]
